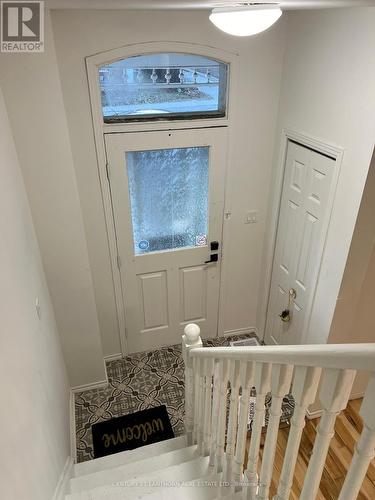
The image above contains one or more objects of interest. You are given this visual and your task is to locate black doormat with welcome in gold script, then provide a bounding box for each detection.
[92,405,174,458]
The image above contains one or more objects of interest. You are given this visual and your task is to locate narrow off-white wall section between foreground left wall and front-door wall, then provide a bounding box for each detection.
[0,12,105,386]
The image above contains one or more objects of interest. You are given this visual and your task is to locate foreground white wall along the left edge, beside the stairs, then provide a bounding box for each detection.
[0,86,70,500]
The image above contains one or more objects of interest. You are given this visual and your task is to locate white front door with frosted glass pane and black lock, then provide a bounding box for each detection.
[105,128,227,352]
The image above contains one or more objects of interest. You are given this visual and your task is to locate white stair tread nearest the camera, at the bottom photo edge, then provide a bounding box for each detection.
[65,457,212,500]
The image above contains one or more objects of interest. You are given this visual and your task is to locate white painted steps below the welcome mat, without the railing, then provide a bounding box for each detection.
[66,436,234,500]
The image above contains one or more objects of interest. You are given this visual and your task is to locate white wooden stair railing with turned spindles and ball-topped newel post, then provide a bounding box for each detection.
[182,324,375,500]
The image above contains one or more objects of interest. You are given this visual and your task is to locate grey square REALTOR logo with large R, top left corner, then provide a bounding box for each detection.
[0,1,44,52]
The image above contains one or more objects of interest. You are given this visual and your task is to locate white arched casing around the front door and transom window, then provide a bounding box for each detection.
[86,41,238,356]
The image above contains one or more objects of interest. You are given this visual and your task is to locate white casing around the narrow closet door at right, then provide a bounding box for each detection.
[258,129,344,344]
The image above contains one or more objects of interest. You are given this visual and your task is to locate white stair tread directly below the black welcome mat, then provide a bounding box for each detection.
[74,436,186,477]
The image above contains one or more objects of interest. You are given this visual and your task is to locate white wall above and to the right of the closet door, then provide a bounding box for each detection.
[258,8,375,343]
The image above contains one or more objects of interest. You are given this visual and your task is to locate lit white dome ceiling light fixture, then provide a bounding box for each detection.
[210,3,282,36]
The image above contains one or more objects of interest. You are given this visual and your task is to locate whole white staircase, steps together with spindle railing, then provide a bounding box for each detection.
[66,324,375,500]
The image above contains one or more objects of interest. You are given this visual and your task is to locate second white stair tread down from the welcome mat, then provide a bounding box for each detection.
[70,445,199,493]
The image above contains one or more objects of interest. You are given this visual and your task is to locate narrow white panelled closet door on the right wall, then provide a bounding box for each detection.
[266,141,335,344]
